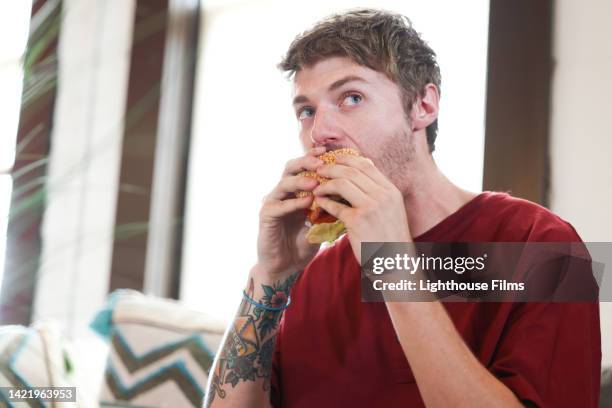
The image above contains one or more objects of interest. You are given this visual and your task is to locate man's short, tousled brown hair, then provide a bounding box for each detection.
[278,9,441,152]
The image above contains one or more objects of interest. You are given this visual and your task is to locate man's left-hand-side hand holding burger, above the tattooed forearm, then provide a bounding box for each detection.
[255,146,325,279]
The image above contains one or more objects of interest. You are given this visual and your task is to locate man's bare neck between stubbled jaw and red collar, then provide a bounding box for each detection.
[404,147,477,237]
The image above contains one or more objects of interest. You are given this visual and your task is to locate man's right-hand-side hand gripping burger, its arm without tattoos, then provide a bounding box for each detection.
[313,155,412,264]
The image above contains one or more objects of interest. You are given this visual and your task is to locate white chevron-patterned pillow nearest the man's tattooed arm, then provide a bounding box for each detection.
[92,290,224,408]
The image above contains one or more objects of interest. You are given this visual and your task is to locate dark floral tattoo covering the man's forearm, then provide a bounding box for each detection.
[205,273,299,407]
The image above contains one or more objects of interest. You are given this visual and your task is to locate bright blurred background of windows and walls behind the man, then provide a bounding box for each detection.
[0,0,612,404]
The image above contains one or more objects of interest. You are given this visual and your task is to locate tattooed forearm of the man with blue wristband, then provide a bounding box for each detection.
[204,268,298,408]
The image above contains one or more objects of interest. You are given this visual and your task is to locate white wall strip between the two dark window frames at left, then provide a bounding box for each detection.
[33,0,135,337]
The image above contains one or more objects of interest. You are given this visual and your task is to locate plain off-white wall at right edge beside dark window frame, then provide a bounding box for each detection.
[550,0,612,365]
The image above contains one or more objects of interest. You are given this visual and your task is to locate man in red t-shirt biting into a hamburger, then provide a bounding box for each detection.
[207,10,601,407]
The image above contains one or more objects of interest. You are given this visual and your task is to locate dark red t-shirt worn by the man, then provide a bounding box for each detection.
[272,192,601,408]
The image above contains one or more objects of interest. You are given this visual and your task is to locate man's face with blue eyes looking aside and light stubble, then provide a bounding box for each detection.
[293,57,415,191]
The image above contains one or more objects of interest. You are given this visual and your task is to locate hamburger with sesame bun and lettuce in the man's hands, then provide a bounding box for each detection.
[295,148,360,244]
